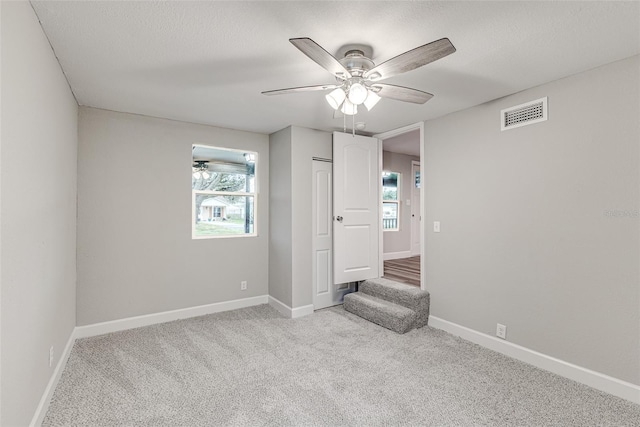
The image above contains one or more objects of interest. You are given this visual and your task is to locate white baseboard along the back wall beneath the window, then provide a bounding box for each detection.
[75,295,269,338]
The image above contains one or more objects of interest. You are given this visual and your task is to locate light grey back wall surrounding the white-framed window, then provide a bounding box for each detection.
[77,107,269,326]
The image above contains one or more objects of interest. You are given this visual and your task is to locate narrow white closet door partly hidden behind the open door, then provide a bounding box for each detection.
[311,160,350,310]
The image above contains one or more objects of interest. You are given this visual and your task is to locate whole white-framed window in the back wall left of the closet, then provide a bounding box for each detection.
[191,145,258,239]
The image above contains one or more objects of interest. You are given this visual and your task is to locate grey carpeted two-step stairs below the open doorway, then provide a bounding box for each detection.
[344,278,429,334]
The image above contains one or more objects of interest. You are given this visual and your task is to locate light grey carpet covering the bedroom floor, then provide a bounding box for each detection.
[44,305,640,426]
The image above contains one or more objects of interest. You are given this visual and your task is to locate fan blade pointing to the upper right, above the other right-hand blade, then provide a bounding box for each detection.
[364,38,456,80]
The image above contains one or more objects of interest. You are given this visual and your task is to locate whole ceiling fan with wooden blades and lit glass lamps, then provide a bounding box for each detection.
[262,37,456,115]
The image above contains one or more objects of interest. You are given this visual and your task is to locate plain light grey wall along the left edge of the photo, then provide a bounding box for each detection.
[0,2,78,426]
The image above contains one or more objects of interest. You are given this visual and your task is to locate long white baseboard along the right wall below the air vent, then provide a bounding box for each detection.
[429,316,640,404]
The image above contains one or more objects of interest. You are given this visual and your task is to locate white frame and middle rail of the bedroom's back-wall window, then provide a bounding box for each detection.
[191,144,260,240]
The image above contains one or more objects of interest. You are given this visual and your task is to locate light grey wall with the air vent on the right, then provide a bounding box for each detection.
[424,56,640,384]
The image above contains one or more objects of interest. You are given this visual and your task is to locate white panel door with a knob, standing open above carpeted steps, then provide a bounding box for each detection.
[333,132,382,284]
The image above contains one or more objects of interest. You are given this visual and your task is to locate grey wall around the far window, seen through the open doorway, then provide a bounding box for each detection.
[382,150,420,256]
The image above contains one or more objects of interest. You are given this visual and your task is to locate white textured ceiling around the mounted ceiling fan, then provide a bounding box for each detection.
[33,1,640,133]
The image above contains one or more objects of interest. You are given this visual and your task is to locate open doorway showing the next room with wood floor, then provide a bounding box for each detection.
[376,123,424,289]
